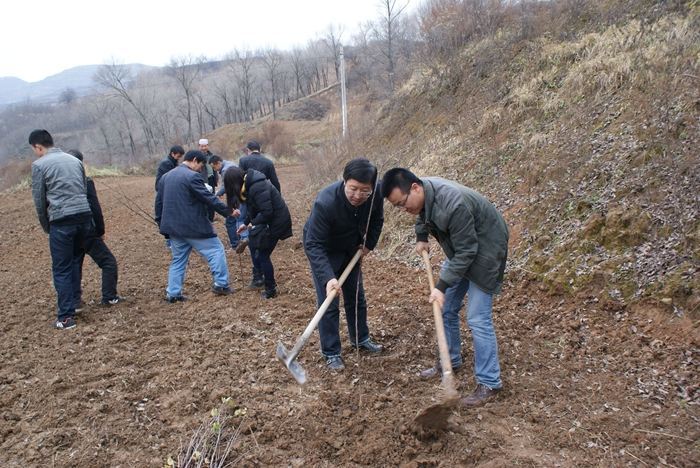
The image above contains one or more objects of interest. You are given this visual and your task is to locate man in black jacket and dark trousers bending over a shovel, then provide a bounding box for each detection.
[302,158,384,370]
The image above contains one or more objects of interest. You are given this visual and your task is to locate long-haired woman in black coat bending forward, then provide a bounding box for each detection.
[224,167,292,299]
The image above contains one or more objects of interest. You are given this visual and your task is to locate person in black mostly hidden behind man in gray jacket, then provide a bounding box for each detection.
[68,149,124,312]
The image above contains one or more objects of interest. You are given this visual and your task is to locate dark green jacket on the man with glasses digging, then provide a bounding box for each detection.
[415,177,509,294]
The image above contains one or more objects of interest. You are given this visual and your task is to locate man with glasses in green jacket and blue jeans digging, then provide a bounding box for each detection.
[382,168,509,407]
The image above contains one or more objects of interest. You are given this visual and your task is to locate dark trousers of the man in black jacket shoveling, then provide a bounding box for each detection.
[312,256,369,357]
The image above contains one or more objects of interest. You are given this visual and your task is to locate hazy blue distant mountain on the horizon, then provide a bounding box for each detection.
[0,64,156,109]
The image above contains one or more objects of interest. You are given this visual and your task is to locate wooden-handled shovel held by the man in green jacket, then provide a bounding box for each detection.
[414,250,459,429]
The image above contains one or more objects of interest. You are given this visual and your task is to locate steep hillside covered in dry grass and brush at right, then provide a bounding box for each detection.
[350,0,700,320]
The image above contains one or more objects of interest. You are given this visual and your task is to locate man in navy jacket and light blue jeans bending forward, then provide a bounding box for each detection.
[156,150,235,303]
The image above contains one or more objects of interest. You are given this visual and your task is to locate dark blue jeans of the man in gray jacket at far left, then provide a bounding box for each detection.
[49,224,90,320]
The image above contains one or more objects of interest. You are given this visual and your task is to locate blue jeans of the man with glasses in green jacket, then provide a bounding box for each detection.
[440,260,502,388]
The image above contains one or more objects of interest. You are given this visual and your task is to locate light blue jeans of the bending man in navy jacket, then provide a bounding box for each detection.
[165,236,229,297]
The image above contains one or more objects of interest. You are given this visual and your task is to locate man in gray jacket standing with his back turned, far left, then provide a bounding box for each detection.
[29,130,92,330]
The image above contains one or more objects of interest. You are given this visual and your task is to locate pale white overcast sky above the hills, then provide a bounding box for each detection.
[0,0,410,82]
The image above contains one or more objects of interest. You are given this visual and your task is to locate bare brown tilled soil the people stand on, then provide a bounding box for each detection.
[0,166,700,468]
